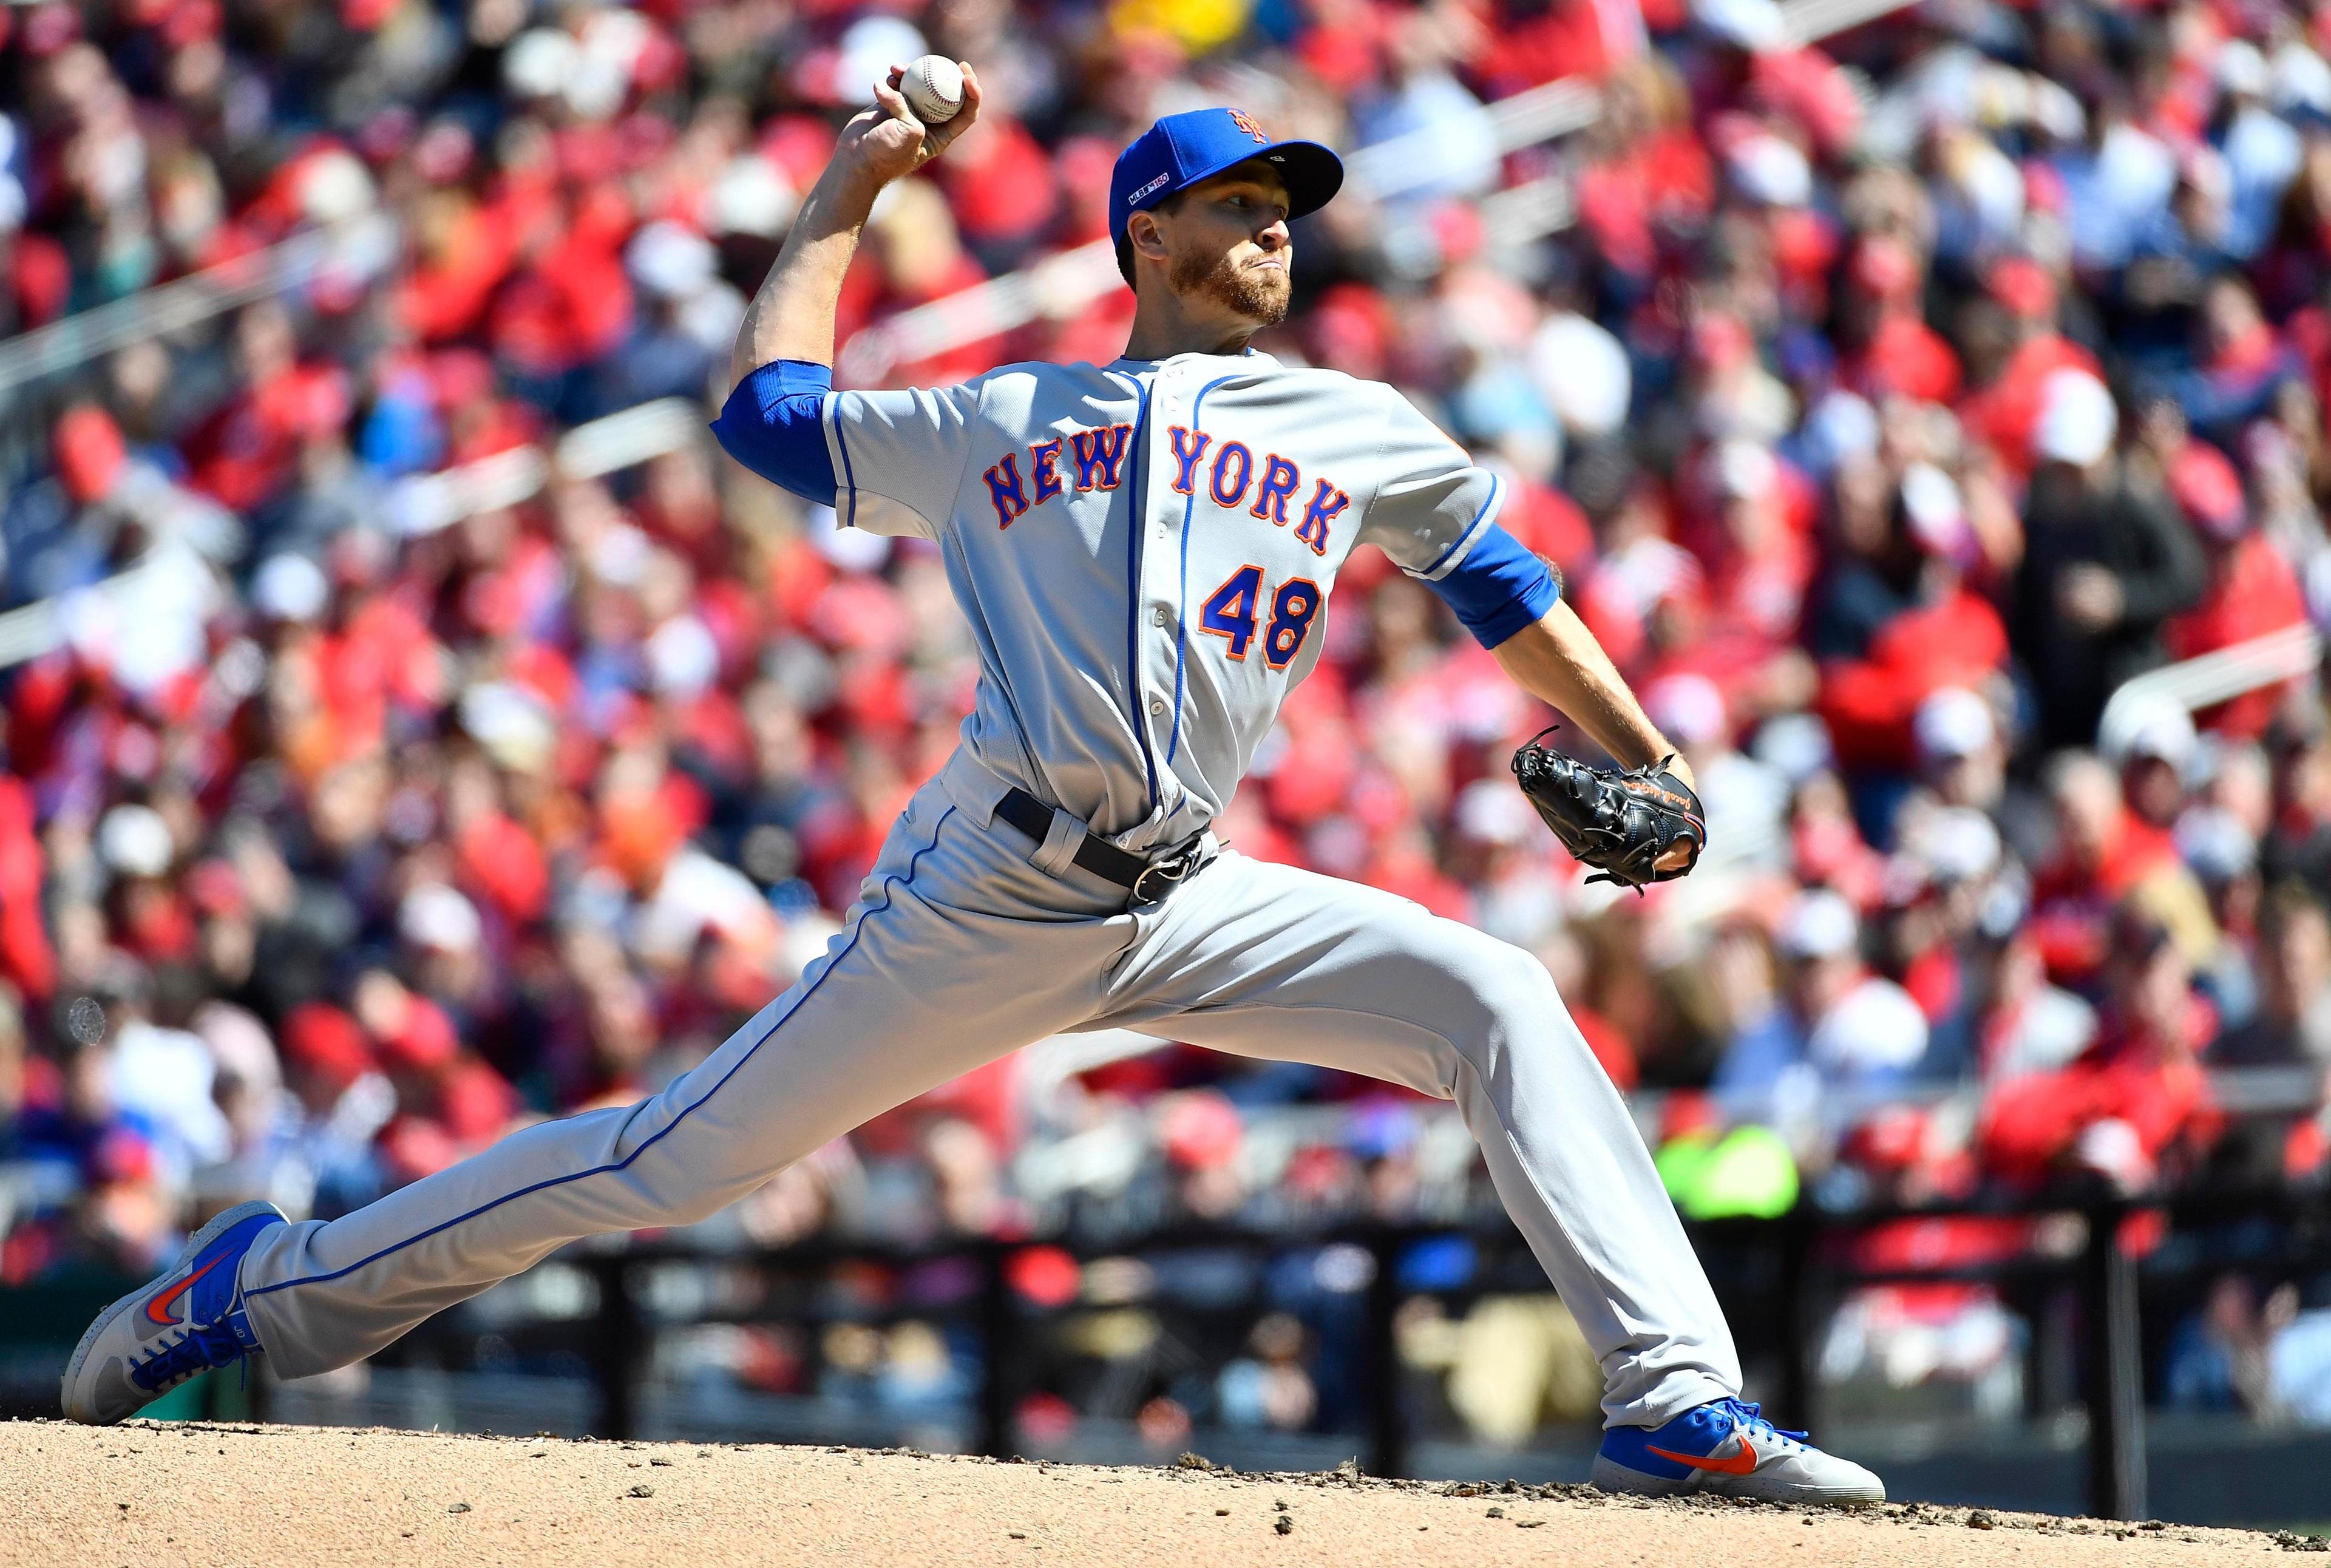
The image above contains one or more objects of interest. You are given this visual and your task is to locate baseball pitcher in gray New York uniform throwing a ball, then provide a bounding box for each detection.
[63,67,1884,1503]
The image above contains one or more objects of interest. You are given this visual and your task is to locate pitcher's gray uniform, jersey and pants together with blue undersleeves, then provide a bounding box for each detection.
[227,354,1739,1426]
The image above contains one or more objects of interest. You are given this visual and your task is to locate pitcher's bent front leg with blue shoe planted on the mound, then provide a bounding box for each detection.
[1107,853,1884,1501]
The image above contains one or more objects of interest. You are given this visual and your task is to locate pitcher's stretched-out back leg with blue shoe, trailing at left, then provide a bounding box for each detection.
[66,790,1128,1421]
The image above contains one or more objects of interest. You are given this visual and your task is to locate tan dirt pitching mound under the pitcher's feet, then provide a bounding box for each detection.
[0,1421,2319,1568]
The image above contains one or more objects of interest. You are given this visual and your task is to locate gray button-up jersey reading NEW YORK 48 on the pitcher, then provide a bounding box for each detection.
[823,352,1501,850]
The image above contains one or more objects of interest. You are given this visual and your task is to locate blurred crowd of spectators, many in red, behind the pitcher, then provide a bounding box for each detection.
[0,0,2331,1435]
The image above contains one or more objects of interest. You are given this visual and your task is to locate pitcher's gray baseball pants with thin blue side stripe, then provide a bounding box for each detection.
[242,755,1739,1426]
